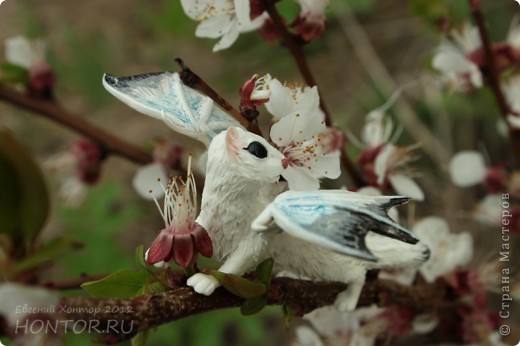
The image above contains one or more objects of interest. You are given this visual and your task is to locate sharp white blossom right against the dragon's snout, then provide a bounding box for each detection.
[265,79,342,190]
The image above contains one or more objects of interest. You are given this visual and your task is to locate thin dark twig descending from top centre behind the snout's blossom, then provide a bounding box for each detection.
[263,0,366,187]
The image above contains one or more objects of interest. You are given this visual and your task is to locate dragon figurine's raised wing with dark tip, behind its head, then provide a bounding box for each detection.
[103,72,240,146]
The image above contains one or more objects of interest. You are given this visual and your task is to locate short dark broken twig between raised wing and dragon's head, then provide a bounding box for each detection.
[175,58,262,136]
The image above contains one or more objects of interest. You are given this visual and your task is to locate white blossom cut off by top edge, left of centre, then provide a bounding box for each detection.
[181,0,266,52]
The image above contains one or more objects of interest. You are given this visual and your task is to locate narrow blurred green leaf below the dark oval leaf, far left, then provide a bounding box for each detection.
[11,236,83,275]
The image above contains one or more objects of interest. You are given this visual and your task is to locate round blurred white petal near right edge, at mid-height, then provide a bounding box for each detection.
[450,151,486,187]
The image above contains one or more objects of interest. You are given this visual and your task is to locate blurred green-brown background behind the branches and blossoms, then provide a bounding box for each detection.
[0,0,519,345]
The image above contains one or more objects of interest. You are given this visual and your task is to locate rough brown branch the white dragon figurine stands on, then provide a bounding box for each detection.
[21,278,450,343]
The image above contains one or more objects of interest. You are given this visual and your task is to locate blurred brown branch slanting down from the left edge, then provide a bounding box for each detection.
[0,85,153,164]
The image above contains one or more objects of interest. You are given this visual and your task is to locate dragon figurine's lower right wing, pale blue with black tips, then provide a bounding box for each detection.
[270,190,418,261]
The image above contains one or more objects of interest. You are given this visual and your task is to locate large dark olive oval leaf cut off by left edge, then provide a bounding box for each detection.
[0,127,49,248]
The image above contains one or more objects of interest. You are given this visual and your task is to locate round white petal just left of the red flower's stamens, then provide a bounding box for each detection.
[132,163,168,200]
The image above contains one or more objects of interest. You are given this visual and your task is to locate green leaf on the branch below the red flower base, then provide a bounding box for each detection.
[81,269,148,298]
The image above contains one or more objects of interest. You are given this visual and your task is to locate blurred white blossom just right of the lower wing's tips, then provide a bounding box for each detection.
[413,217,473,282]
